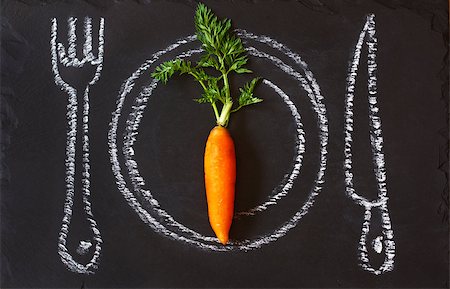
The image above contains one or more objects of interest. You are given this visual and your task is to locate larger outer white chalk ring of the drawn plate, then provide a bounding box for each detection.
[108,30,328,251]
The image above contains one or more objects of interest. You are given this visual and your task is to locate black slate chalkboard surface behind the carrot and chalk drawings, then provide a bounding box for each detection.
[1,0,449,288]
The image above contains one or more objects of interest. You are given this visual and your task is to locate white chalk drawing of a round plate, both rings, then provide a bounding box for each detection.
[108,30,328,251]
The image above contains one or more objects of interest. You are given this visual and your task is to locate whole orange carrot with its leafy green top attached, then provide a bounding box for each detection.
[152,3,262,244]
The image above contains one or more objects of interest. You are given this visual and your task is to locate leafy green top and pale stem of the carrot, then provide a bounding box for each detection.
[152,3,262,127]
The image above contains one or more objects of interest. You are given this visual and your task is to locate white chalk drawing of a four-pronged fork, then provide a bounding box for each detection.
[50,17,104,274]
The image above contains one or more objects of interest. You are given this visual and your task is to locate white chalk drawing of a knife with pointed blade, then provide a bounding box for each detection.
[344,14,395,275]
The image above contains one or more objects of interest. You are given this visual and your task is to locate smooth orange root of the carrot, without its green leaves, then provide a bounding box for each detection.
[205,125,236,245]
